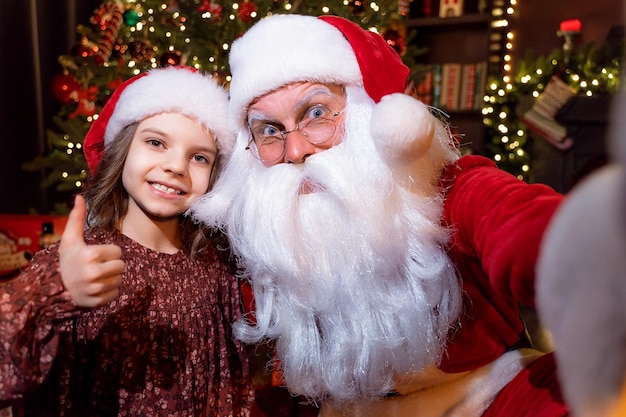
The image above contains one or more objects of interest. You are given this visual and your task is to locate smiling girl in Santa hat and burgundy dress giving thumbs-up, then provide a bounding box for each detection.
[0,67,252,417]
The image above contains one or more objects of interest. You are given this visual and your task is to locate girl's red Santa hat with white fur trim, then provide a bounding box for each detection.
[83,67,235,174]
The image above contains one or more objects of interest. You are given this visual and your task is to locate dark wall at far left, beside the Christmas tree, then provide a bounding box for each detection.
[0,0,100,213]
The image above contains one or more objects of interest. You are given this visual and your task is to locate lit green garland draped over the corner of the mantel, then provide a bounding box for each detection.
[482,39,624,180]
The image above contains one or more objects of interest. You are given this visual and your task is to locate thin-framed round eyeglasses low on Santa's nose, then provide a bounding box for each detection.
[246,104,343,163]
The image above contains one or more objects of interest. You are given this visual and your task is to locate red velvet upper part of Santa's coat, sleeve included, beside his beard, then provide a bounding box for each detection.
[440,156,563,373]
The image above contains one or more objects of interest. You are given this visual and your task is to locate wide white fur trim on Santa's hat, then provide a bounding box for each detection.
[229,15,363,128]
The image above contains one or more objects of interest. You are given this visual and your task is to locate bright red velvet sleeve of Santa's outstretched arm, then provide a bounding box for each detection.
[445,157,563,306]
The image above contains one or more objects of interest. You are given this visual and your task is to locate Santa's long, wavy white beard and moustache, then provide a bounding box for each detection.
[192,88,461,401]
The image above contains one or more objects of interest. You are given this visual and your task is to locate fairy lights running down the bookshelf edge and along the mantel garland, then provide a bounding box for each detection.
[481,0,622,180]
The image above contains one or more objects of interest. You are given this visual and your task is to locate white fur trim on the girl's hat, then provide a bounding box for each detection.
[104,67,235,155]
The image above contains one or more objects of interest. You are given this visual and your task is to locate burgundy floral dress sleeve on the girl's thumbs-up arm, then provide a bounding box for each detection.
[0,245,79,400]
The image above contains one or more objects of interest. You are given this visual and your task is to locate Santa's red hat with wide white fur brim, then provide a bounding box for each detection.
[229,15,410,127]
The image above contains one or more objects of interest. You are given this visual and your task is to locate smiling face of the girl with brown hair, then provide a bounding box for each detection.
[122,113,217,221]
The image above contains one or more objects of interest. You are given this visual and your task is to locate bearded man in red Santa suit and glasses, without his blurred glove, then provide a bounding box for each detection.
[192,15,567,417]
